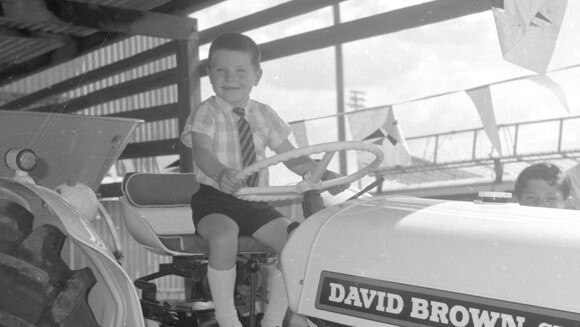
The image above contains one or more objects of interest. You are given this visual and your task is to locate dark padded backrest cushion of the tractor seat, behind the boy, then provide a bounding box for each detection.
[122,173,199,207]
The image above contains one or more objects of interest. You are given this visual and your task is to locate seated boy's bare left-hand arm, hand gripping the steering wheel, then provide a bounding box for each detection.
[191,132,243,194]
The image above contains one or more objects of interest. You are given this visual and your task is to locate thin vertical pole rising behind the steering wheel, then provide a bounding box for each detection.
[332,4,348,175]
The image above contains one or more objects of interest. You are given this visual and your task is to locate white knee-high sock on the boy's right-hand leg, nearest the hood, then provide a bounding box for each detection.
[262,269,288,327]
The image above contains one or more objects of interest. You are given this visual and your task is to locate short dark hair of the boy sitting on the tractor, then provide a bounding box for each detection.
[207,33,262,69]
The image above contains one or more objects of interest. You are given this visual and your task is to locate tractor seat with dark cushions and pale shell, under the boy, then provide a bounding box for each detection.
[120,173,274,257]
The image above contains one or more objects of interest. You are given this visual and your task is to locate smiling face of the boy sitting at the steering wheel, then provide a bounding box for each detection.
[208,50,262,106]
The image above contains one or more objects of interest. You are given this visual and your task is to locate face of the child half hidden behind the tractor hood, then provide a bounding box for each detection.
[519,179,564,208]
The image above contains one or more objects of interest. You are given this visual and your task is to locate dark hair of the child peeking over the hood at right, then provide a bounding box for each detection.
[514,162,570,199]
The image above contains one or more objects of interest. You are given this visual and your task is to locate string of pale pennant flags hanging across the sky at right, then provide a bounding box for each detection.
[291,0,574,172]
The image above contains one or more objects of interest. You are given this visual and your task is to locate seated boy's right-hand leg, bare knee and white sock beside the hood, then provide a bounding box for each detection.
[253,218,290,327]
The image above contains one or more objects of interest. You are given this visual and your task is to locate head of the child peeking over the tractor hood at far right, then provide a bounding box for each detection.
[514,162,570,208]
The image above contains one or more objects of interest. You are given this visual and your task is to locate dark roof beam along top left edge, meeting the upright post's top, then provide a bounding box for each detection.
[0,0,197,39]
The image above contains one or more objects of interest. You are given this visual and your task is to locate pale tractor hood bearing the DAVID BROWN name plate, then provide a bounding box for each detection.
[281,197,580,326]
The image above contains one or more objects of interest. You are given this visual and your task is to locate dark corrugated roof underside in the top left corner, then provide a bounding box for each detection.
[0,0,179,83]
